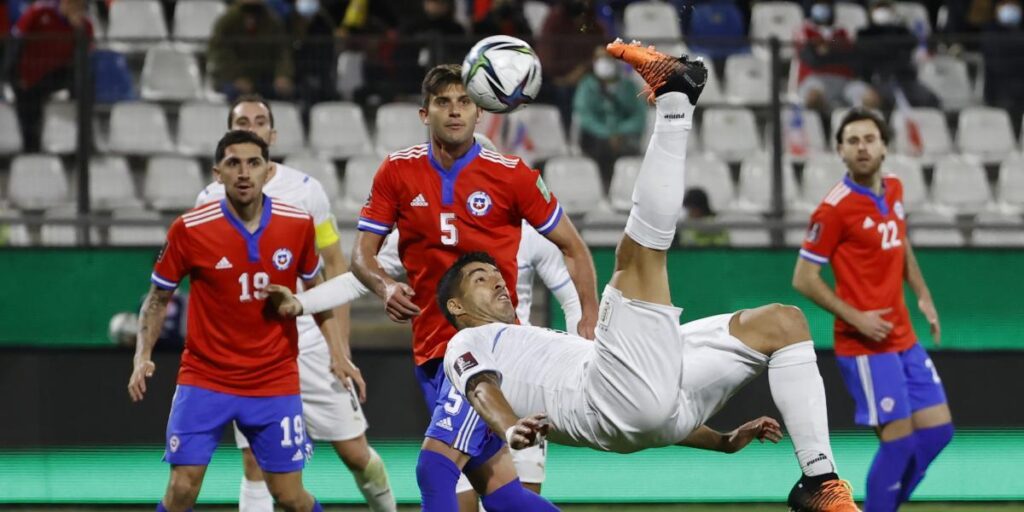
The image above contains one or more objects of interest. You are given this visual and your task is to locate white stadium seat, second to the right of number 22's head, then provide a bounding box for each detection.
[956,106,1017,163]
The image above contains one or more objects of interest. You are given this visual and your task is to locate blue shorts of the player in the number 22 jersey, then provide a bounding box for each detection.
[836,343,946,427]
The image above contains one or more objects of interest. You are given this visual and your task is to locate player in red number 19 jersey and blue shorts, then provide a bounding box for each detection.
[128,130,331,511]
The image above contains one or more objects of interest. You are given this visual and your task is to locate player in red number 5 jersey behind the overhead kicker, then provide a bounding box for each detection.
[352,65,597,503]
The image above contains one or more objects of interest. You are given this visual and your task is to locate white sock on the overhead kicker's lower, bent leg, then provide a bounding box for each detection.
[768,341,837,476]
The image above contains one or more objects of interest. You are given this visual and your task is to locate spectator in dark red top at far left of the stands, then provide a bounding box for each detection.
[0,0,92,153]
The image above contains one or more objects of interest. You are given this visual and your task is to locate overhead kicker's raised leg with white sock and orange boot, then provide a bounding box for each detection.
[607,40,708,304]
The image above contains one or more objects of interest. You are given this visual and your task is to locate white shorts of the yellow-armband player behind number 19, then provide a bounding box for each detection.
[234,343,368,449]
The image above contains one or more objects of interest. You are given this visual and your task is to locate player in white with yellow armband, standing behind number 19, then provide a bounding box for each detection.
[196,96,396,512]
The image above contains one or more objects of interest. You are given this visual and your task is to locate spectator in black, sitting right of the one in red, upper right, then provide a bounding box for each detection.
[855,0,939,108]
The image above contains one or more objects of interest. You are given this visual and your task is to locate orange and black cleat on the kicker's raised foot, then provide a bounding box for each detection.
[605,39,708,104]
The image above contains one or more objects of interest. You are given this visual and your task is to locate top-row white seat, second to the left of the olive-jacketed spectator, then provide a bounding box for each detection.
[106,0,167,52]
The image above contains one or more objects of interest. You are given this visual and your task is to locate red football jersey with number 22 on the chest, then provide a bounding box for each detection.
[800,174,918,355]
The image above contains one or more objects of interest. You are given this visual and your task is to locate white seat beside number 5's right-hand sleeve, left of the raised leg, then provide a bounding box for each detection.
[544,157,604,216]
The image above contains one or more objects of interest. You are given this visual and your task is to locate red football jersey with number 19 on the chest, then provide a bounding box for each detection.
[153,196,321,396]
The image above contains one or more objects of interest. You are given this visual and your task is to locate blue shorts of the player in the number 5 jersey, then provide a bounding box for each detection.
[416,359,505,470]
